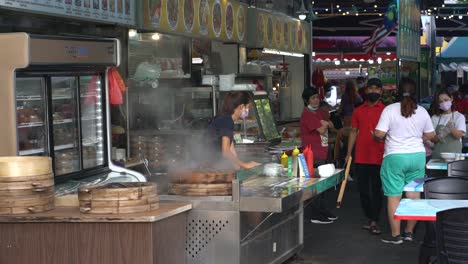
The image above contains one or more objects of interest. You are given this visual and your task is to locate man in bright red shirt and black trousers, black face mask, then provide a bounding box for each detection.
[346,78,385,234]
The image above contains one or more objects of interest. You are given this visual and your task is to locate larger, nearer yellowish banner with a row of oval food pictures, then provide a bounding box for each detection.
[139,0,247,43]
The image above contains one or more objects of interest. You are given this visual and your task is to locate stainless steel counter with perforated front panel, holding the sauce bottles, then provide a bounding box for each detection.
[160,161,344,264]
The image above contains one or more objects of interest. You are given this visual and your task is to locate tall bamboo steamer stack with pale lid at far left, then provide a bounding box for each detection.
[0,156,55,214]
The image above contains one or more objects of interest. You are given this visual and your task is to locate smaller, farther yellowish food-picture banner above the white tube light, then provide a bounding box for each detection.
[247,8,311,54]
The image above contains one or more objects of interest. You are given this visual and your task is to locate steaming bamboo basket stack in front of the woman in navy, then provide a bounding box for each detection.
[169,167,235,196]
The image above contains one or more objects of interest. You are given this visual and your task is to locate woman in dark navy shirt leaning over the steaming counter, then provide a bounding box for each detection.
[208,92,260,169]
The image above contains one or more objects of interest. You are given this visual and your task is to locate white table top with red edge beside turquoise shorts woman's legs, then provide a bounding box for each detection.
[393,199,468,221]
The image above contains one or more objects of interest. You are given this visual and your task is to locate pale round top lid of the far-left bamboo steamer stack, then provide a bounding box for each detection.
[0,156,52,177]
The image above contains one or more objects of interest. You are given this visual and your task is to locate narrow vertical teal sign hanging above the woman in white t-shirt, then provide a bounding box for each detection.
[397,0,421,61]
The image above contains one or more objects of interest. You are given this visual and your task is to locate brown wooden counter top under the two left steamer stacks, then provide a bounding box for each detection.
[0,202,192,223]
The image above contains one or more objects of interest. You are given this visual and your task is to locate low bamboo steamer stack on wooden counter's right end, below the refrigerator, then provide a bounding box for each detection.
[78,182,159,214]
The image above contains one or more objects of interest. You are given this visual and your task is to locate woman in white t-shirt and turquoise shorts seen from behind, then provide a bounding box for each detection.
[371,78,435,244]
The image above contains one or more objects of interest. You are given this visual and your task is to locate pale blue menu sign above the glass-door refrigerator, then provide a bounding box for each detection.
[0,0,135,26]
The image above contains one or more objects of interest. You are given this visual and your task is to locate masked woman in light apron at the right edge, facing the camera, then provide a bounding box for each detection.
[432,90,466,159]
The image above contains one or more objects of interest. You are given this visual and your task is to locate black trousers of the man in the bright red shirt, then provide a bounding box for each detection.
[355,163,383,222]
